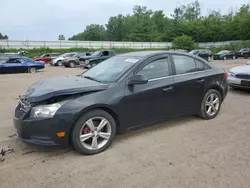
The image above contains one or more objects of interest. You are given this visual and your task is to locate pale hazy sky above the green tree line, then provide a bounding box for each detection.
[0,0,250,40]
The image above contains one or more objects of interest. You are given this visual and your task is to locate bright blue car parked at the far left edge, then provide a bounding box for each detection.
[0,57,45,73]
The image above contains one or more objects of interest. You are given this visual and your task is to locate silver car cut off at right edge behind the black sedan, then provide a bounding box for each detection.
[228,65,250,89]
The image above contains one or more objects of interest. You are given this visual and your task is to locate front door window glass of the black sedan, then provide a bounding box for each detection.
[137,58,170,80]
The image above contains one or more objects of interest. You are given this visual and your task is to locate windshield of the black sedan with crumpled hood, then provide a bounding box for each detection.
[82,56,140,83]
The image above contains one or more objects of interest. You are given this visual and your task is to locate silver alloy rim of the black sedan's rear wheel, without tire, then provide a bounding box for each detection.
[205,93,220,116]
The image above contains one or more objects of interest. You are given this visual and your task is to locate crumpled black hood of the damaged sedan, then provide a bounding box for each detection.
[25,76,109,103]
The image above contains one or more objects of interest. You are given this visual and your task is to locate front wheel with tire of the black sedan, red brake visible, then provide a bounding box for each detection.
[72,110,116,155]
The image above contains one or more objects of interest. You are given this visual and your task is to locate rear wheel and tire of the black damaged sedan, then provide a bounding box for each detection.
[199,89,222,120]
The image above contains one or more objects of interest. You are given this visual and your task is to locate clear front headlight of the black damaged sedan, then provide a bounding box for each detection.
[30,101,67,118]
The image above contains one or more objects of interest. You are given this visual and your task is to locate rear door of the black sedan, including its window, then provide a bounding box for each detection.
[172,54,208,115]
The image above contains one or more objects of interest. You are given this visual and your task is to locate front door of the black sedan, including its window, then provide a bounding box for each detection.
[122,56,174,128]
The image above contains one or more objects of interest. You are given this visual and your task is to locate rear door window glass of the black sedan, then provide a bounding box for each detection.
[173,55,196,74]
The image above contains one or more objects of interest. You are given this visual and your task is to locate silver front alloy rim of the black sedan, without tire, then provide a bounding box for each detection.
[79,117,112,150]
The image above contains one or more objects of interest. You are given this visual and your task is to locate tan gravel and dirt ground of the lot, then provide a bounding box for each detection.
[0,60,250,188]
